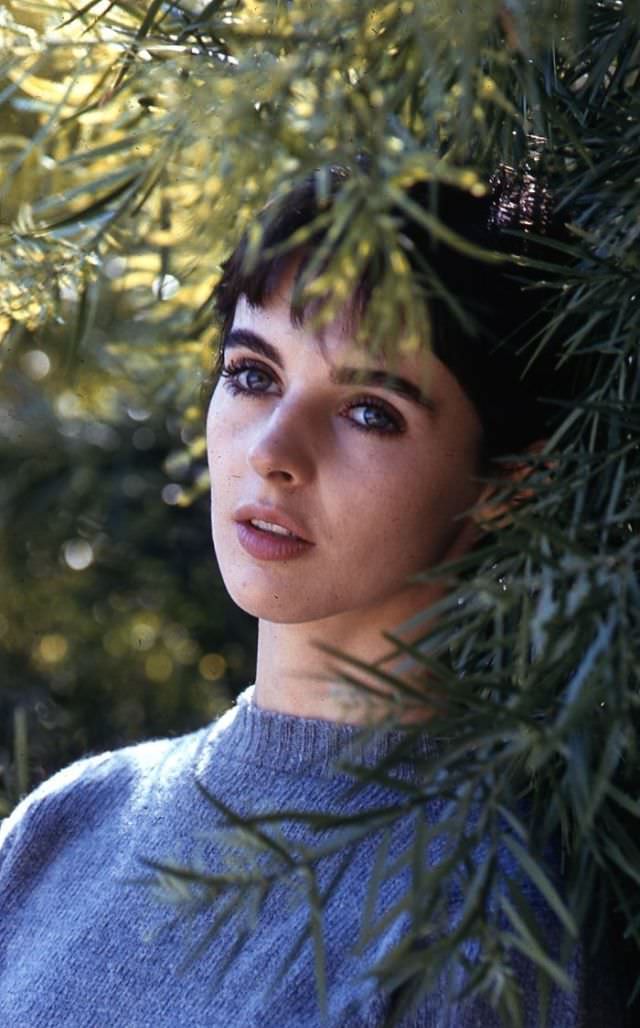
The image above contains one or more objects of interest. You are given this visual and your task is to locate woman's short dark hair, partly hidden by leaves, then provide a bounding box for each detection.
[214,167,577,460]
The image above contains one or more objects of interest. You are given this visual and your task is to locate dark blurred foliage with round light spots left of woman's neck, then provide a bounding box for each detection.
[0,333,255,803]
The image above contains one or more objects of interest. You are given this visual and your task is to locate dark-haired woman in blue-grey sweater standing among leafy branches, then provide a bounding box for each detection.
[0,164,622,1028]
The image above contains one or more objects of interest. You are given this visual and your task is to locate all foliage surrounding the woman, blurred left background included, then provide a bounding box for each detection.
[0,0,640,1024]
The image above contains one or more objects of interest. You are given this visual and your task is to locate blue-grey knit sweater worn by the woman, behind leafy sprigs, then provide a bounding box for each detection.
[0,689,618,1028]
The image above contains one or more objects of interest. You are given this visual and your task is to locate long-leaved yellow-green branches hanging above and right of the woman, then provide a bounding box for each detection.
[0,0,640,1025]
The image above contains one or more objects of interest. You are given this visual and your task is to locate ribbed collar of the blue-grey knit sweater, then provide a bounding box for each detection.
[198,686,442,779]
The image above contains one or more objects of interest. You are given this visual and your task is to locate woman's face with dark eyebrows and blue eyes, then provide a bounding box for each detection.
[206,274,482,627]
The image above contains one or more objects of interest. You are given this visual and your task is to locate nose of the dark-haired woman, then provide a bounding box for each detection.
[248,398,315,484]
